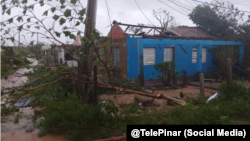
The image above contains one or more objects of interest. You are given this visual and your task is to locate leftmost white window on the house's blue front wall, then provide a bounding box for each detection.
[143,48,155,65]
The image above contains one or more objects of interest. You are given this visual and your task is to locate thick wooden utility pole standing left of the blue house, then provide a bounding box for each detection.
[77,0,97,103]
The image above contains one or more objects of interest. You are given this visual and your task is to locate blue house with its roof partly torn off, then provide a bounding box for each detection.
[109,21,244,80]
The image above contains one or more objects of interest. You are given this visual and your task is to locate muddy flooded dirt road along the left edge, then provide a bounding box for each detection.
[0,58,68,141]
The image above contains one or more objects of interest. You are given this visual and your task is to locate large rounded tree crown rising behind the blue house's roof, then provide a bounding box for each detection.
[189,2,244,38]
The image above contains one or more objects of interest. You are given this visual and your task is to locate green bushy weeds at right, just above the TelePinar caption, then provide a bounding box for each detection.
[169,81,250,125]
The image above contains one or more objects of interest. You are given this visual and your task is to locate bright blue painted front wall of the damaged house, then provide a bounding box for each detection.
[127,36,244,80]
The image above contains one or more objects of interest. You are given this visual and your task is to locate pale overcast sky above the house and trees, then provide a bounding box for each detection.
[0,0,250,43]
